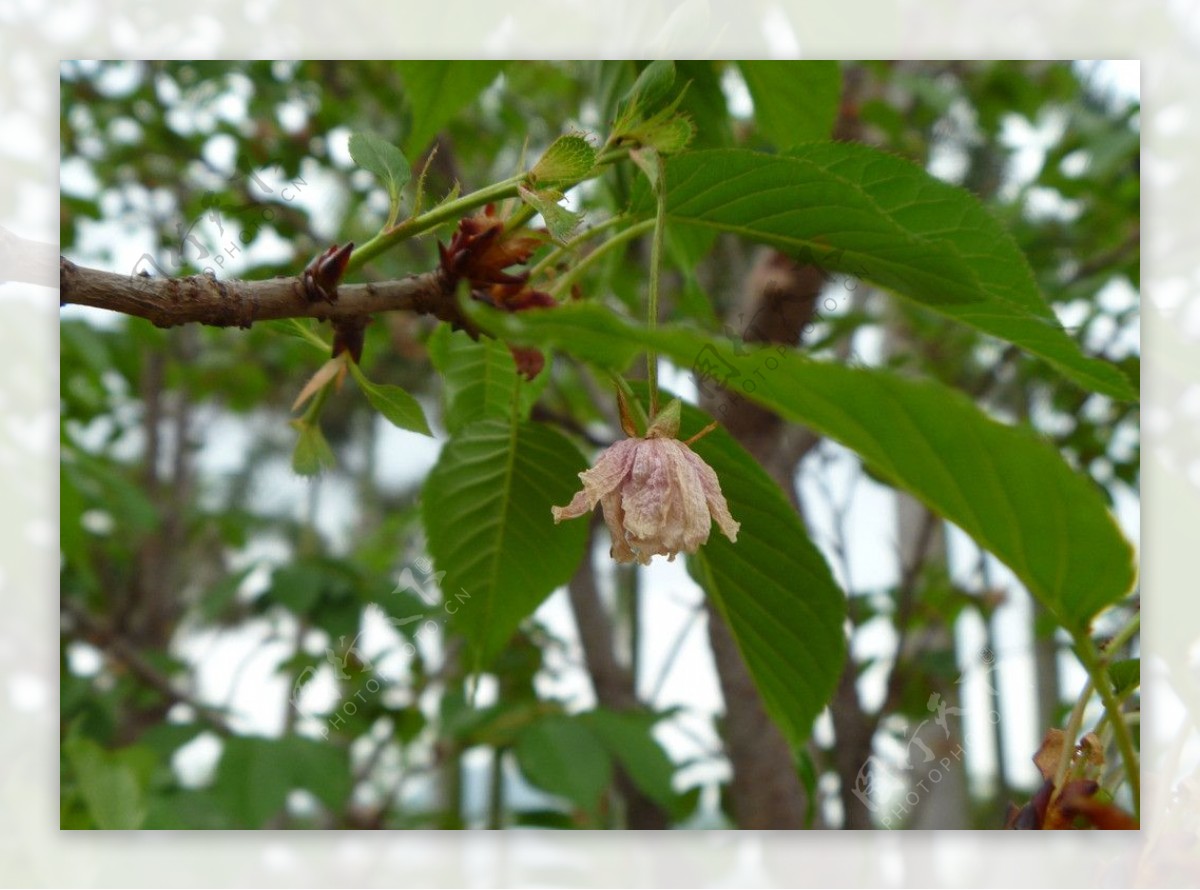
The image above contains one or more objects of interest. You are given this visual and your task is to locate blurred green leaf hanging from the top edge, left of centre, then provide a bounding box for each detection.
[396,59,504,157]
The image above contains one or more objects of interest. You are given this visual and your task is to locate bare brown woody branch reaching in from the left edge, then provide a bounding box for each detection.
[59,257,474,331]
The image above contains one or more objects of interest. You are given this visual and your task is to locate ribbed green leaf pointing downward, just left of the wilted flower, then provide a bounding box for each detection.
[421,420,587,668]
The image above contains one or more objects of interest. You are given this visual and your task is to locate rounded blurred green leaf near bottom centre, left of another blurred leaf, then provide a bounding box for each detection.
[516,715,612,811]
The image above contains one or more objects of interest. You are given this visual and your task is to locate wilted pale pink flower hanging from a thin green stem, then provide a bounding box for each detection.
[551,402,740,565]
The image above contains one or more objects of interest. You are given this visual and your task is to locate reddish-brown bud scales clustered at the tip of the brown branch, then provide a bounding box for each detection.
[438,204,557,379]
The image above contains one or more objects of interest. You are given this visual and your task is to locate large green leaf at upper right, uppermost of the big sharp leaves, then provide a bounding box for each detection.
[635,143,1136,399]
